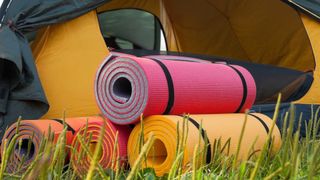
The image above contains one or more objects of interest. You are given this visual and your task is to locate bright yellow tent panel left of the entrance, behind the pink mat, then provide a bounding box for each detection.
[32,11,108,118]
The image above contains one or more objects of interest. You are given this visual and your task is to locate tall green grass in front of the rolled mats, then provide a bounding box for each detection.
[0,100,320,180]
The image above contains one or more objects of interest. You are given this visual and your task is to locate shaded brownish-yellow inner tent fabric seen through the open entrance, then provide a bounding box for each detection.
[98,0,316,72]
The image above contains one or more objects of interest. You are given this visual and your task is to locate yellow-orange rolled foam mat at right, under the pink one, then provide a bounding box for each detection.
[128,113,281,176]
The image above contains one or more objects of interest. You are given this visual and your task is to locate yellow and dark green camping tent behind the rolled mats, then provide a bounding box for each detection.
[0,0,320,138]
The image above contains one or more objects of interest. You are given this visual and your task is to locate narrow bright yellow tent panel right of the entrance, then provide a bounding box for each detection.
[298,14,320,104]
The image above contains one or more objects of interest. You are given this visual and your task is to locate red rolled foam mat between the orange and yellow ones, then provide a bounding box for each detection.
[71,118,131,175]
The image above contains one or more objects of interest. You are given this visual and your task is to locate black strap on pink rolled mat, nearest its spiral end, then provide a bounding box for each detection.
[151,59,174,114]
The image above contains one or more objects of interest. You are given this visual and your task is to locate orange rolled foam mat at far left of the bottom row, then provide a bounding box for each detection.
[1,120,73,173]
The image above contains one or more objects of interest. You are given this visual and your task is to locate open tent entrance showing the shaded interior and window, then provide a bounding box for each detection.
[98,6,315,104]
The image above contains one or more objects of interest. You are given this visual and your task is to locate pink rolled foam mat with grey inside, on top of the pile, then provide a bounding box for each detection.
[95,55,256,124]
